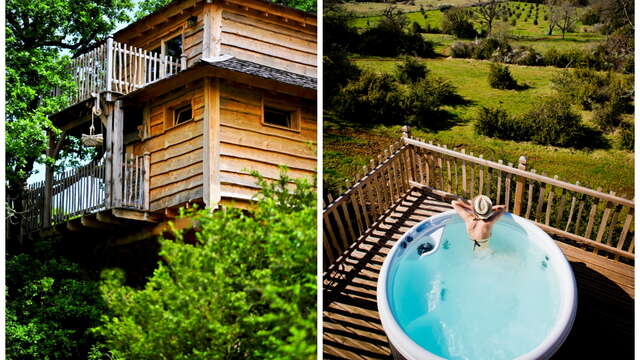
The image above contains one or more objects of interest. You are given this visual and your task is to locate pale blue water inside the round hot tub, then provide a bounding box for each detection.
[387,216,559,360]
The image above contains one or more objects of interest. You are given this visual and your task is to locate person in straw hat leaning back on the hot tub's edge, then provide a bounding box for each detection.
[451,195,505,249]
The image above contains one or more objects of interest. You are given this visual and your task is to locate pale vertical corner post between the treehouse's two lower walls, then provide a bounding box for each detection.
[202,77,220,209]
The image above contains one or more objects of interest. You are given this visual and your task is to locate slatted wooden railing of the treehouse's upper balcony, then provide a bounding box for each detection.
[70,38,186,103]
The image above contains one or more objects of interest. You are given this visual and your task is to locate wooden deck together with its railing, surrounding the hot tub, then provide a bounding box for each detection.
[322,128,635,360]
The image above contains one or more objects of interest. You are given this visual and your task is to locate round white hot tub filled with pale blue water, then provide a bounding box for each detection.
[377,210,577,360]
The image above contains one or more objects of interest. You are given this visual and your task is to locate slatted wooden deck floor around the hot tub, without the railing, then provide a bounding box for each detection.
[323,189,634,360]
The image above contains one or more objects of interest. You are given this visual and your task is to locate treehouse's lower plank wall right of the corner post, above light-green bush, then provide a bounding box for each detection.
[220,80,317,200]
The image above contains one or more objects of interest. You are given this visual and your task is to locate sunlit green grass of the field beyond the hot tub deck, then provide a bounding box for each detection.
[324,58,634,197]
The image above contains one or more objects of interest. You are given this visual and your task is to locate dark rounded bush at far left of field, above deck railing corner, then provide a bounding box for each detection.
[333,71,405,125]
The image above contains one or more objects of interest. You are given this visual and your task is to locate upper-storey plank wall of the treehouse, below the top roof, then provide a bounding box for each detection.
[221,7,317,77]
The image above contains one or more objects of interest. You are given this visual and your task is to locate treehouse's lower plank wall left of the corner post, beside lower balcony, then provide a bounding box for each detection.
[135,81,204,211]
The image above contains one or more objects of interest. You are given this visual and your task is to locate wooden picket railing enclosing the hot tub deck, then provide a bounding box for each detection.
[324,128,634,269]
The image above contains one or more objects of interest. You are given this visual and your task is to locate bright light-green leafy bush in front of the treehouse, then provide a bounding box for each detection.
[94,175,316,360]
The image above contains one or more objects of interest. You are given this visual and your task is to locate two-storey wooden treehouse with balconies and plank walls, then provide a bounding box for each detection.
[22,0,317,242]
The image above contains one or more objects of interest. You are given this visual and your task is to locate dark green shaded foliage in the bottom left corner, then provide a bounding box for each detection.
[5,250,106,360]
